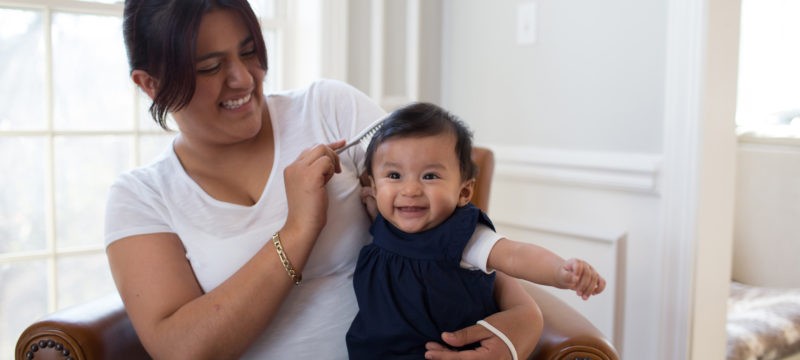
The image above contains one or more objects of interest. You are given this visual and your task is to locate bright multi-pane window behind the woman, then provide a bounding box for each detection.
[0,0,287,357]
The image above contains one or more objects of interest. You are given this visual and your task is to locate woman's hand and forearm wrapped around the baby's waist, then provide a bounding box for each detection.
[425,272,544,360]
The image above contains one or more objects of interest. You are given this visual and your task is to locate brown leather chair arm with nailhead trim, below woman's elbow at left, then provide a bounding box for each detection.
[15,293,150,360]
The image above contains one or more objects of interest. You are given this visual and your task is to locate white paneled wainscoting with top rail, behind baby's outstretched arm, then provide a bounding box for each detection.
[481,144,663,354]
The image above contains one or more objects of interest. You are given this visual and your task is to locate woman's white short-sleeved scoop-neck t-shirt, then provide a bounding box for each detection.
[105,80,491,359]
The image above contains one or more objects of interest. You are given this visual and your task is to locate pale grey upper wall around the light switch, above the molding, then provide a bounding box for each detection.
[443,0,666,153]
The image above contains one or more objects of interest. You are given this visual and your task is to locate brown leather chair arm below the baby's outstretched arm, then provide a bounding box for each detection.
[521,281,619,360]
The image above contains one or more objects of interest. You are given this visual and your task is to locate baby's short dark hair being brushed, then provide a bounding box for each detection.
[364,102,478,180]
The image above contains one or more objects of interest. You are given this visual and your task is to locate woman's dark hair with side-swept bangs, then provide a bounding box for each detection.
[122,0,267,129]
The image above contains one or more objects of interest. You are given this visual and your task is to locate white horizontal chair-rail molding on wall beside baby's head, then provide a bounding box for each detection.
[482,144,661,196]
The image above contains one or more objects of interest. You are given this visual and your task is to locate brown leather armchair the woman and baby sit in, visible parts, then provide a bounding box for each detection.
[15,148,619,360]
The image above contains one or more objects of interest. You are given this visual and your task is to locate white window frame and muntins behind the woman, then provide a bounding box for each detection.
[0,0,291,350]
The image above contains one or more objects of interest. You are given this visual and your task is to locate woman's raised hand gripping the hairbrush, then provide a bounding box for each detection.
[283,140,345,238]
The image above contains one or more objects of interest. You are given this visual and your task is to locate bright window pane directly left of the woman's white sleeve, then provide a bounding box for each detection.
[55,136,131,249]
